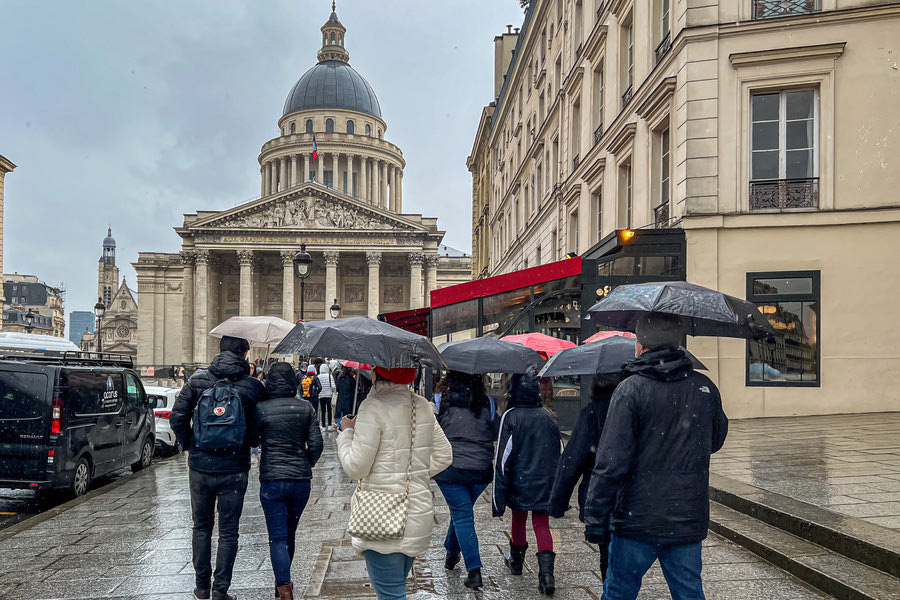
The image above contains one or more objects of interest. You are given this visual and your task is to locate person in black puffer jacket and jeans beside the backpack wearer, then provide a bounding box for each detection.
[256,363,322,600]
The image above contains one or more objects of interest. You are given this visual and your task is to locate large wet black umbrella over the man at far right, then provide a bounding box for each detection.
[588,281,775,338]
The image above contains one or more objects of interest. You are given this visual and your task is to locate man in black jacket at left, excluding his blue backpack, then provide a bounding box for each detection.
[169,336,265,600]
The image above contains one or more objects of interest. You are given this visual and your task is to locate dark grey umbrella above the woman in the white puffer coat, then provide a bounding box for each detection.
[275,317,447,369]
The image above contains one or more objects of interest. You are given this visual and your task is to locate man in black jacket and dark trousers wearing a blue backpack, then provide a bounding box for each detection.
[169,336,265,600]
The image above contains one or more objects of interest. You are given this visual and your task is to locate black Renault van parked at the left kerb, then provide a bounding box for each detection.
[0,352,155,496]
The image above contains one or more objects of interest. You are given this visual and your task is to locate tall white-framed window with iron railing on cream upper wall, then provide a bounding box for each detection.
[750,90,819,210]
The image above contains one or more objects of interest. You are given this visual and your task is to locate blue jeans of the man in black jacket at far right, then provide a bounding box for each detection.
[602,534,706,600]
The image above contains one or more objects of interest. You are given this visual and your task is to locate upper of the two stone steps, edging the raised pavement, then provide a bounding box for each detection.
[709,473,900,578]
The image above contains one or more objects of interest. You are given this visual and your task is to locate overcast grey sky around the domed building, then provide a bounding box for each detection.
[0,0,522,328]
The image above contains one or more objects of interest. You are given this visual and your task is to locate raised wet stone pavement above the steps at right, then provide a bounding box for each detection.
[710,413,900,531]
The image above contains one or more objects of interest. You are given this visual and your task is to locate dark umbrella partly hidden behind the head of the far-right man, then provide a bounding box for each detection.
[538,336,709,377]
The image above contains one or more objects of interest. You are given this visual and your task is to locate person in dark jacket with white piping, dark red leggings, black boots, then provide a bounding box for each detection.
[493,368,562,595]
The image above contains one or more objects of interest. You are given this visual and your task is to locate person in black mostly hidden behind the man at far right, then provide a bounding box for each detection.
[550,375,619,579]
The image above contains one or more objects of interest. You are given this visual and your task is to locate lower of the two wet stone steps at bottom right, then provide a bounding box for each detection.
[709,502,900,600]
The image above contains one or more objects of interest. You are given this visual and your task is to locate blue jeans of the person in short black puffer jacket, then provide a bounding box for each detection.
[259,479,310,585]
